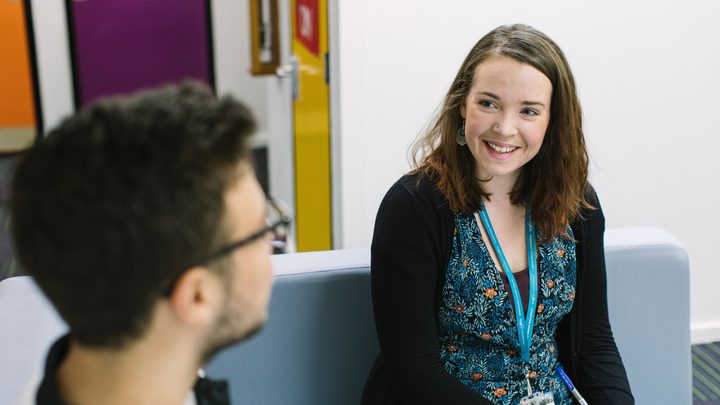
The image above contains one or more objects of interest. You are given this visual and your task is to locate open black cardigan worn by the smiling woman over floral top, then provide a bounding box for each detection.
[362,175,634,405]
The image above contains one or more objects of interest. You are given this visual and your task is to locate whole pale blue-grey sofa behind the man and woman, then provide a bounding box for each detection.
[0,228,692,405]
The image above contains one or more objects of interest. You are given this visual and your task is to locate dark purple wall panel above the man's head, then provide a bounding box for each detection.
[70,0,212,106]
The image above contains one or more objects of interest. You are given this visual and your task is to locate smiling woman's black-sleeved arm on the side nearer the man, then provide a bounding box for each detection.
[371,178,490,405]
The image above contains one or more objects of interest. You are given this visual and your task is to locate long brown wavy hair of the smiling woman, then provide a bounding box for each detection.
[411,24,592,241]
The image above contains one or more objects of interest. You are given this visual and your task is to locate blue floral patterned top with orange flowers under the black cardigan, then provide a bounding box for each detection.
[439,214,576,405]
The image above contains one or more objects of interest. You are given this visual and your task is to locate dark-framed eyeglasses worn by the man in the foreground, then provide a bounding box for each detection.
[163,199,292,296]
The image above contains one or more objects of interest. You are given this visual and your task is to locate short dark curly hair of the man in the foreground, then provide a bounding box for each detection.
[11,82,255,347]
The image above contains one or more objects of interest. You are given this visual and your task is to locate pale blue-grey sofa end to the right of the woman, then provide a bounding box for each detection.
[605,228,692,405]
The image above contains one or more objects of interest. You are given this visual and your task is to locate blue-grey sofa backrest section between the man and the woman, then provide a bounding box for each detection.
[206,249,379,405]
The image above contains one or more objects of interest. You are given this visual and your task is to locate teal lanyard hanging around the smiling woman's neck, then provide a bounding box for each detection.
[478,206,538,362]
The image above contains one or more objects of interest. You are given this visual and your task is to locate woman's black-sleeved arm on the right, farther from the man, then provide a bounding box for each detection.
[576,190,635,405]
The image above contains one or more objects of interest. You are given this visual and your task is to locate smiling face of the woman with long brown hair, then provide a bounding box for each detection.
[460,55,552,184]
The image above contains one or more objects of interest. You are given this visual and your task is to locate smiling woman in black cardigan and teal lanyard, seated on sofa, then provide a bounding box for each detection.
[362,25,633,405]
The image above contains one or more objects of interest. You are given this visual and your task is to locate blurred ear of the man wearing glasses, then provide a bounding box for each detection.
[169,266,225,326]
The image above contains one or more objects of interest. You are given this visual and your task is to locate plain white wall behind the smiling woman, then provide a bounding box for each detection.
[335,0,720,341]
